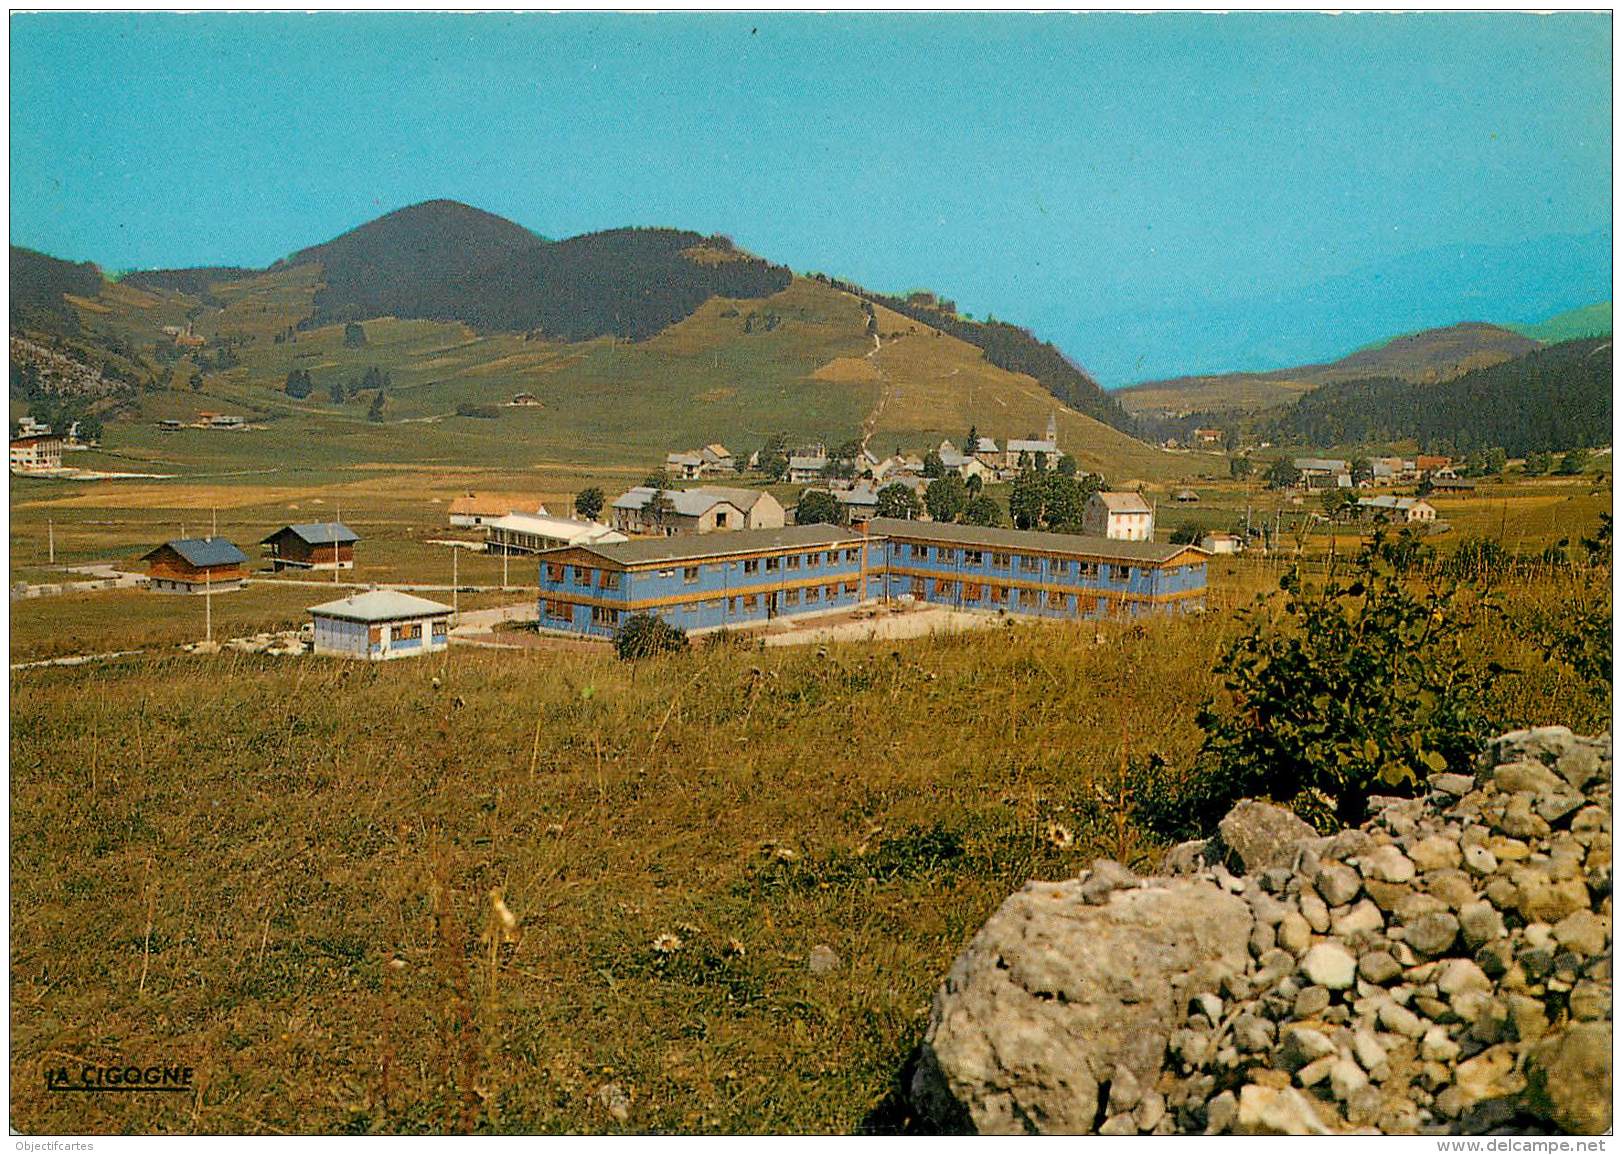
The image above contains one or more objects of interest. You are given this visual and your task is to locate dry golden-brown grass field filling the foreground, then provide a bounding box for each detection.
[11,564,1609,1132]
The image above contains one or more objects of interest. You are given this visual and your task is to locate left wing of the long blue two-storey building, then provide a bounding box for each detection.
[539,526,884,638]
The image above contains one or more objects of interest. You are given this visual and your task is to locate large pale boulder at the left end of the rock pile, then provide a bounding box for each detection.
[912,876,1252,1134]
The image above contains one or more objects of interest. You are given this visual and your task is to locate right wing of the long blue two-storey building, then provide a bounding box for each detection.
[868,517,1207,618]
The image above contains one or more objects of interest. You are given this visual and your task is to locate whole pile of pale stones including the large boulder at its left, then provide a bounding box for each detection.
[912,727,1612,1134]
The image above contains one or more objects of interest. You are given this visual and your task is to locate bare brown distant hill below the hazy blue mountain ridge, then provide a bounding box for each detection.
[1114,321,1538,415]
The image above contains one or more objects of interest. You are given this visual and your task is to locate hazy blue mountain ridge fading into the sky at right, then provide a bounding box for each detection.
[1083,230,1611,381]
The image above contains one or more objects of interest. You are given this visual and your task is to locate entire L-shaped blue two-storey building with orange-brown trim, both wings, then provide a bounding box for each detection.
[539,517,1208,638]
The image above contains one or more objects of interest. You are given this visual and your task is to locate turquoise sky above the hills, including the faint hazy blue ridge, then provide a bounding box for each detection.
[10,13,1611,384]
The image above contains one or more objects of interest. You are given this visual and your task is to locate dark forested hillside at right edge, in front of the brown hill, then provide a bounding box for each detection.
[1257,337,1612,456]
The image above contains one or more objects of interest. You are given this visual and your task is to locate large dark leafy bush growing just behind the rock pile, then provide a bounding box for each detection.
[1197,534,1486,822]
